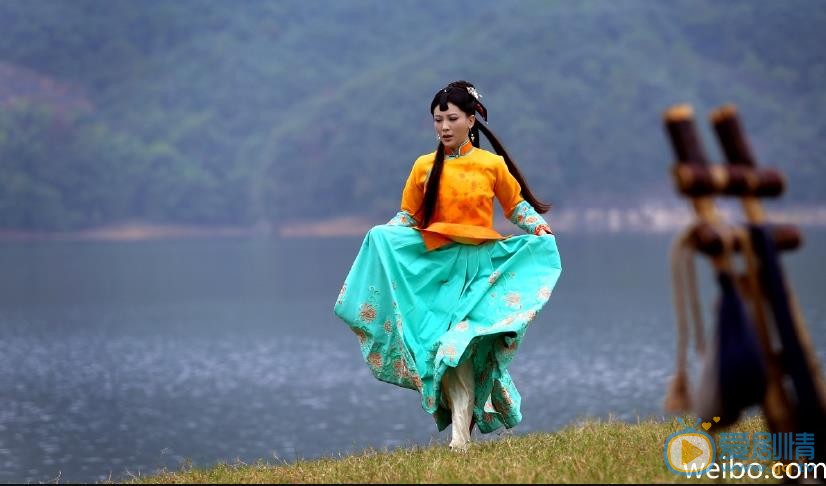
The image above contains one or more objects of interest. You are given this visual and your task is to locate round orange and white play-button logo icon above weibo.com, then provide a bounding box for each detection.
[663,418,715,475]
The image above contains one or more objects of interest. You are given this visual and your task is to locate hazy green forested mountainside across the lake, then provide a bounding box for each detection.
[0,0,826,229]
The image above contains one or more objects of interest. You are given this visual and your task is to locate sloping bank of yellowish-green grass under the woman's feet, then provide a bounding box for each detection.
[120,417,768,483]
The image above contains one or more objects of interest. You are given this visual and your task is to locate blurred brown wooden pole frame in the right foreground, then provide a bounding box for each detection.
[664,105,826,468]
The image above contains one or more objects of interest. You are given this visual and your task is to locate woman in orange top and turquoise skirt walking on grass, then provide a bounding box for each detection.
[335,81,562,450]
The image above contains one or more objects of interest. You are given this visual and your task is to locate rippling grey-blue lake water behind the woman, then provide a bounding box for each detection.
[0,231,826,482]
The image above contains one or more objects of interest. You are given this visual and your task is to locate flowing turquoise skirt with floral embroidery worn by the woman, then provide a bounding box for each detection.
[334,225,562,433]
